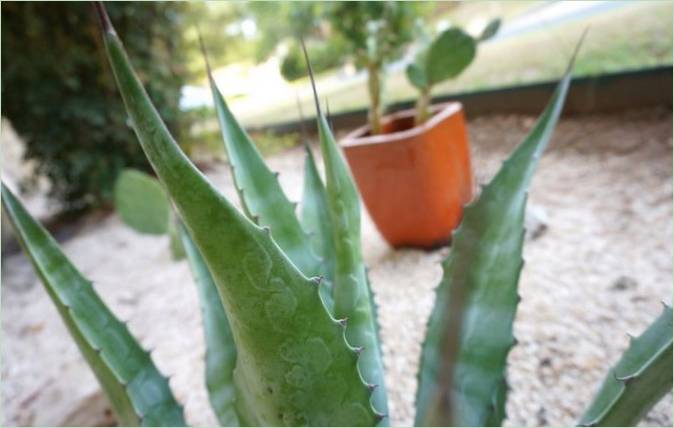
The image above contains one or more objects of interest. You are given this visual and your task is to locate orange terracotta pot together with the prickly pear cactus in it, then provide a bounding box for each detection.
[342,19,500,248]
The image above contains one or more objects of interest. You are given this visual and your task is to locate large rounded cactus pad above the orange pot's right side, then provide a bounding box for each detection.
[426,28,476,85]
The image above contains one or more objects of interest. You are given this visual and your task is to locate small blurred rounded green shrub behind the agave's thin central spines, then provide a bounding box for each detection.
[281,39,347,81]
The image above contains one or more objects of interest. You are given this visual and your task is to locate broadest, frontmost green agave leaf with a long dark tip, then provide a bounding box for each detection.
[99,6,377,426]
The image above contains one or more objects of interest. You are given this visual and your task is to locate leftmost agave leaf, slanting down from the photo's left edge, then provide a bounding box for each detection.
[2,184,185,426]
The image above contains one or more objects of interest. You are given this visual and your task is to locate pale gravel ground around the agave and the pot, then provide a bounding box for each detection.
[1,110,672,426]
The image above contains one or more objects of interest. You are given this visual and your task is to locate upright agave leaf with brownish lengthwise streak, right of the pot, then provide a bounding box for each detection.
[415,51,575,426]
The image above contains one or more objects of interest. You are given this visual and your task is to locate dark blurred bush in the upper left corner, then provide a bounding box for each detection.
[2,2,187,210]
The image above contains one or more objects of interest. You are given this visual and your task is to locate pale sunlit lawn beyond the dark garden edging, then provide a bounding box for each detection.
[227,1,672,128]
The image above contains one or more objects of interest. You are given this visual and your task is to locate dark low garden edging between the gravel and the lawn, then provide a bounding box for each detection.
[249,65,672,133]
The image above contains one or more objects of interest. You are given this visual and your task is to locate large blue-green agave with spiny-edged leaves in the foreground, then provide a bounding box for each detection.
[2,5,672,426]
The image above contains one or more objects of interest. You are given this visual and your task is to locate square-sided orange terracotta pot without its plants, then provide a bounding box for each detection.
[341,102,473,248]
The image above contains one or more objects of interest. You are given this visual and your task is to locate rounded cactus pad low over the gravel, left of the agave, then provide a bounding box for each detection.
[115,169,171,235]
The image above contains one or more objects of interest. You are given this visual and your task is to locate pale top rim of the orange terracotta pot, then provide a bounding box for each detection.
[340,101,463,147]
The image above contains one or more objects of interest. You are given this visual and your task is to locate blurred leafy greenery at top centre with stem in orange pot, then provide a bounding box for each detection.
[242,1,434,133]
